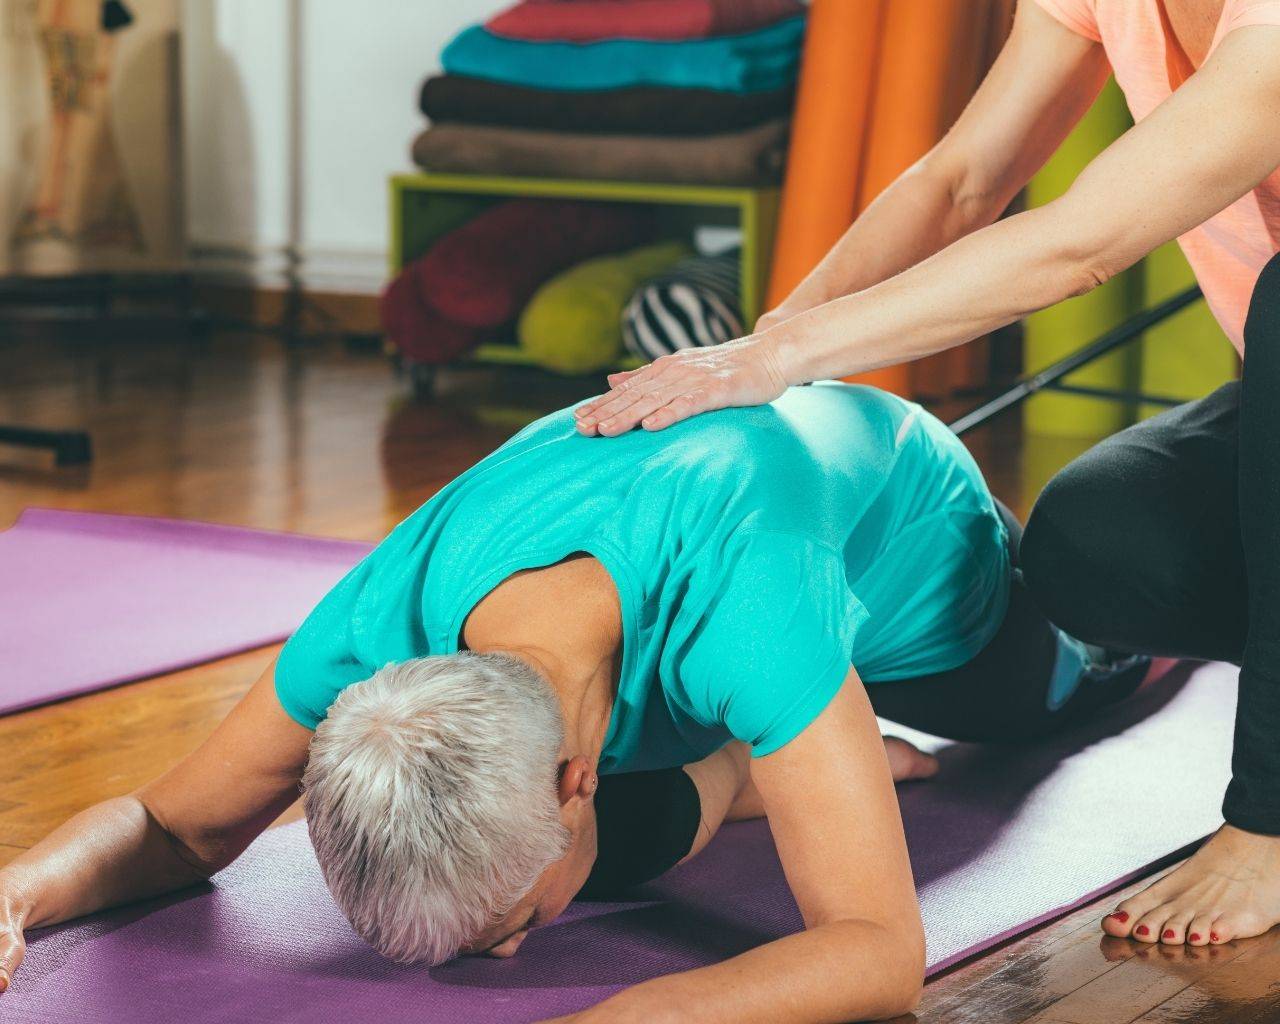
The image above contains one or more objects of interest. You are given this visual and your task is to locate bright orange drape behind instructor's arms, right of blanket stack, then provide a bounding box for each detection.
[768,0,1012,394]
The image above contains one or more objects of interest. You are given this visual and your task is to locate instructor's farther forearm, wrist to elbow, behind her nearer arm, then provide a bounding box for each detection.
[760,154,1009,329]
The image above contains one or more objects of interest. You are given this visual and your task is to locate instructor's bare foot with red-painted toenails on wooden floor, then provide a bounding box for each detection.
[1102,824,1280,946]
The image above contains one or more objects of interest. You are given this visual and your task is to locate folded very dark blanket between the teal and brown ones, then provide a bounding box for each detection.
[420,74,795,136]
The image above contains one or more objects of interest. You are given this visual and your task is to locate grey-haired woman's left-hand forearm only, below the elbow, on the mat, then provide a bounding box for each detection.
[0,796,209,928]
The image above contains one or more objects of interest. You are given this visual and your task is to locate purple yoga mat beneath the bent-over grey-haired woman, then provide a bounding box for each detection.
[0,666,1236,1024]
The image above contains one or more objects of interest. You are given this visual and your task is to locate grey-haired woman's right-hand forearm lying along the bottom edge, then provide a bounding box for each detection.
[560,920,924,1024]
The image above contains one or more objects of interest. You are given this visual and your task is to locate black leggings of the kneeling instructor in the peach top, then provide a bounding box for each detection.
[1021,255,1280,835]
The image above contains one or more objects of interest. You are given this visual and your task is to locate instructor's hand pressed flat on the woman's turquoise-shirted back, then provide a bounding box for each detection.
[573,335,792,436]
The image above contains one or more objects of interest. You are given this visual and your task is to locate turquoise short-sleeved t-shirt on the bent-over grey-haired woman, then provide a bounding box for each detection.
[275,384,1009,772]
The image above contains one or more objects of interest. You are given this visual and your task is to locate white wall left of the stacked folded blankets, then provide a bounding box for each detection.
[182,0,491,292]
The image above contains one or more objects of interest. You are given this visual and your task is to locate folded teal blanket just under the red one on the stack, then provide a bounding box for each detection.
[440,15,804,92]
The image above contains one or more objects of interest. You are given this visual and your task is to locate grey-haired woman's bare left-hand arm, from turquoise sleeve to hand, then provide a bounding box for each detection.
[0,664,312,992]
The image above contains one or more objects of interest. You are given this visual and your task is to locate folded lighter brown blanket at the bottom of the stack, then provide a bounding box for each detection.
[413,119,790,186]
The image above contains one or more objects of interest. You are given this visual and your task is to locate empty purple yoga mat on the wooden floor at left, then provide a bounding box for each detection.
[0,508,370,714]
